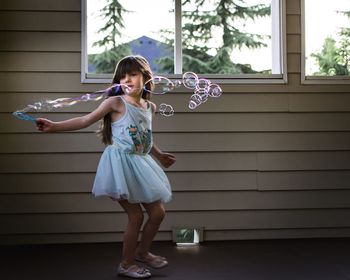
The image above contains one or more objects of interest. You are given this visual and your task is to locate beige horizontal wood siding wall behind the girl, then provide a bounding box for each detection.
[0,0,350,244]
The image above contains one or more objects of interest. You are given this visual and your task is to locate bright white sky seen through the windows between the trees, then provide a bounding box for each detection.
[87,0,350,72]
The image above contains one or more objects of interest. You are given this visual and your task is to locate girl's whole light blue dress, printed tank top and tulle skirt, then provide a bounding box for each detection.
[92,96,171,203]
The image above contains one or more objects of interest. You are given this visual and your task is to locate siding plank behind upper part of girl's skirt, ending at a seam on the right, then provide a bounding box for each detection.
[0,152,257,174]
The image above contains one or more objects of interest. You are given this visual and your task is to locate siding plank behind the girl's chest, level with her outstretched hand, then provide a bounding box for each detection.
[0,112,350,133]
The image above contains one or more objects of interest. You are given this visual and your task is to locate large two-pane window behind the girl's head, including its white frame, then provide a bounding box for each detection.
[82,0,286,83]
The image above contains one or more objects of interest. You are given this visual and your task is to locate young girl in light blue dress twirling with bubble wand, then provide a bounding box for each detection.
[37,56,175,278]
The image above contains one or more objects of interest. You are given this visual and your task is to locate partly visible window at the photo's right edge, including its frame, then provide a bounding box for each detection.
[301,0,350,83]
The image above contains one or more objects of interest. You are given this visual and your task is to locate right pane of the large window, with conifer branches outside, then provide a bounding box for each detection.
[182,0,278,74]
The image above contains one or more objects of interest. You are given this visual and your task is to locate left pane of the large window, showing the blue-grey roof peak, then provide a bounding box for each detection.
[86,0,175,73]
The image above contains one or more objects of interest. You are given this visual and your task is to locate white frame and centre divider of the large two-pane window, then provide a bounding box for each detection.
[81,0,287,84]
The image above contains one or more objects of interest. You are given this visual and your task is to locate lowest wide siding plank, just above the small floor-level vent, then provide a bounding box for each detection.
[0,209,350,236]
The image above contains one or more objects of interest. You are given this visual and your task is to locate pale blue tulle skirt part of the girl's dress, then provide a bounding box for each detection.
[92,145,171,203]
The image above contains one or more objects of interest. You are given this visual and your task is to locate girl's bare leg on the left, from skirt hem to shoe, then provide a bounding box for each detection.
[118,200,143,268]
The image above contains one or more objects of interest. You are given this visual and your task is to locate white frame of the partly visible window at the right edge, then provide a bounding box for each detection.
[300,0,350,84]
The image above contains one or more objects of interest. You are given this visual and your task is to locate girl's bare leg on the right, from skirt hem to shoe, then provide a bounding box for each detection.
[136,201,165,257]
